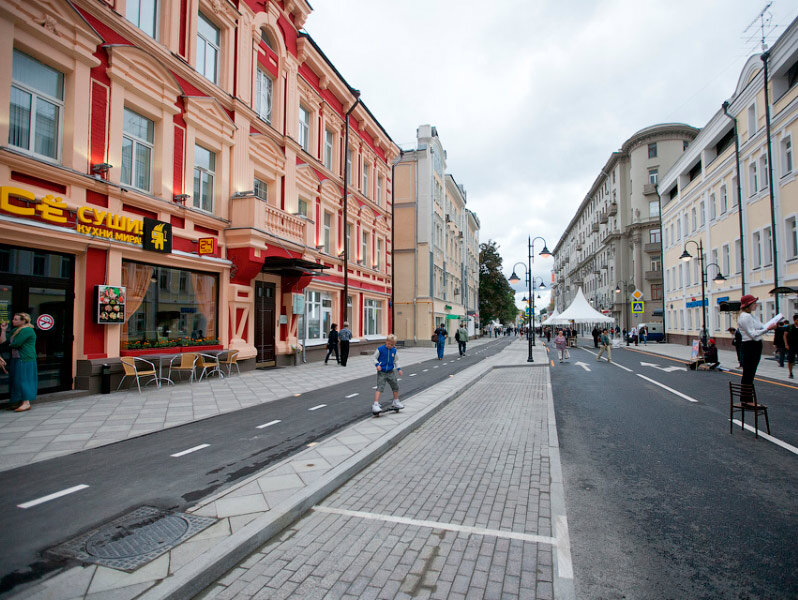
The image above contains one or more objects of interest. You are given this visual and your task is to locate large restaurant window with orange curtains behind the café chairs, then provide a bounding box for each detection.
[122,261,218,348]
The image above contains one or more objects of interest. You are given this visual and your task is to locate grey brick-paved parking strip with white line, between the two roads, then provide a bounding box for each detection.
[200,360,573,600]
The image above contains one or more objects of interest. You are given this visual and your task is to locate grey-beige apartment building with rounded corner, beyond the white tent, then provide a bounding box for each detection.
[553,123,698,329]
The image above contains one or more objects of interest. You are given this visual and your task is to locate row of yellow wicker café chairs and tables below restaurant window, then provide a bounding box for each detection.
[116,350,241,393]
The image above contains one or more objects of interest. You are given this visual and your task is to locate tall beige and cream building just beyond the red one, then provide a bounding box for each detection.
[393,125,479,343]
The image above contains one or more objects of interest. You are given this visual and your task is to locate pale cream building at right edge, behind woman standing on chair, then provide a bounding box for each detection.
[659,20,798,348]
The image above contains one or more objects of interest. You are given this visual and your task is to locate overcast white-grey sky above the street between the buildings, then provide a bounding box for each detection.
[305,0,798,305]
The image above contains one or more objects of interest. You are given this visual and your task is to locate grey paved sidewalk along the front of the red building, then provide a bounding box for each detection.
[0,338,489,471]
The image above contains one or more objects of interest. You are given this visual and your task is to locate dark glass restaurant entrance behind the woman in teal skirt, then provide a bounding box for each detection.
[0,245,75,399]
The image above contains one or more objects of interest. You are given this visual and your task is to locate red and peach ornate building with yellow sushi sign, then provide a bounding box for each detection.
[0,0,399,394]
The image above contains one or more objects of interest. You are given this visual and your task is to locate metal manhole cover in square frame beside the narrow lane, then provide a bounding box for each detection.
[47,506,216,571]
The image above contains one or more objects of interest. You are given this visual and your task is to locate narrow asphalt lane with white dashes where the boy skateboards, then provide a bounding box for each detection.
[0,338,514,593]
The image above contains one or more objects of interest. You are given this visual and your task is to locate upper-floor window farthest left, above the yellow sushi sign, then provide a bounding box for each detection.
[8,49,64,160]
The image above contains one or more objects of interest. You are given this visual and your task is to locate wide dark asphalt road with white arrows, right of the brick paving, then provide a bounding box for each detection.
[551,348,798,600]
